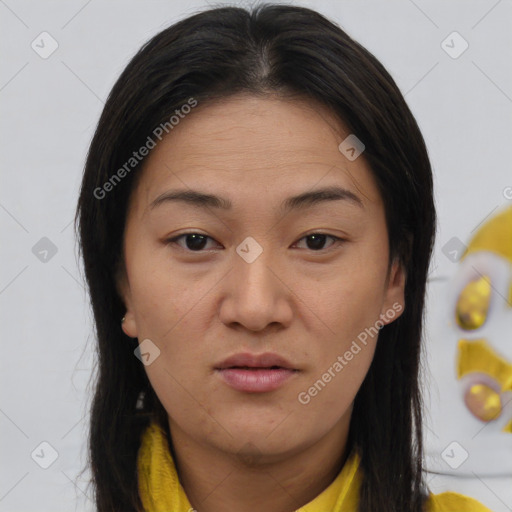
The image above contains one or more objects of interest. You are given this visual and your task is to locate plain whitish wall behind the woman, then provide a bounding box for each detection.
[0,0,512,512]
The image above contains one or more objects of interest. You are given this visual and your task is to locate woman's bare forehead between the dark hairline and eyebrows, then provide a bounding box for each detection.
[128,95,380,216]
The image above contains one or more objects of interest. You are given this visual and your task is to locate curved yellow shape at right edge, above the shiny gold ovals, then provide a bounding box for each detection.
[461,206,512,261]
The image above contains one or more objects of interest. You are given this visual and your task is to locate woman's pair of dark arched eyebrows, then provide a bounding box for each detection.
[149,187,364,213]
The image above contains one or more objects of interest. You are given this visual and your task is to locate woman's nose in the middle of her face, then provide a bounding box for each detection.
[219,251,293,334]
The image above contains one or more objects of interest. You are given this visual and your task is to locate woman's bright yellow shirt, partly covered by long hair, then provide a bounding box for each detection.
[137,424,491,512]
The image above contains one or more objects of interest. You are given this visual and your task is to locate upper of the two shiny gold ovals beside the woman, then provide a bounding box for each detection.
[455,276,491,331]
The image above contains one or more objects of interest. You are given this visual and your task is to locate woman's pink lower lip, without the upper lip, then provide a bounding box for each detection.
[217,368,297,393]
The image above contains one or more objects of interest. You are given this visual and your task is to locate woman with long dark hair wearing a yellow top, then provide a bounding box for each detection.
[77,5,487,512]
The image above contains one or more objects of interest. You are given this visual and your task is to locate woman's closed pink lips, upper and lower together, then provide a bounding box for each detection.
[215,353,298,393]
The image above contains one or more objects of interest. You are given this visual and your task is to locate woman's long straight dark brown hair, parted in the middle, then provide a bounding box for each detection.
[75,4,436,512]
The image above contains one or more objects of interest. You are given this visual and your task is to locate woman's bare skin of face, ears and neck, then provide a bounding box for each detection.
[119,95,405,512]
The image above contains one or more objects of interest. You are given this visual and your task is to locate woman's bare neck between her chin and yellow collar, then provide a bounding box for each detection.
[169,411,351,512]
